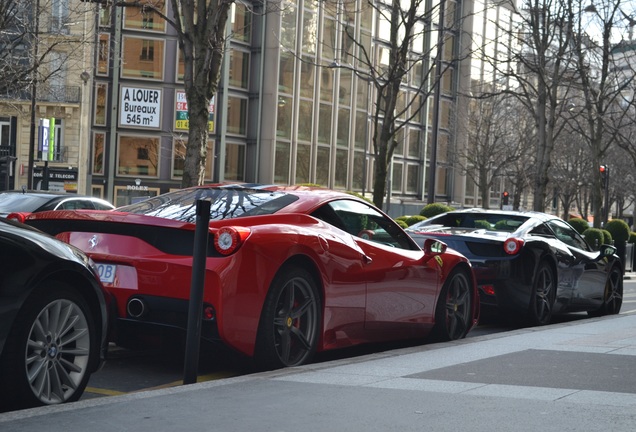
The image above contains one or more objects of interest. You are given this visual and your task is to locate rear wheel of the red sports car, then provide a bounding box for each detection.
[255,268,322,369]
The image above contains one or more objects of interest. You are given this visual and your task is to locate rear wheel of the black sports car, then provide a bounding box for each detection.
[528,261,557,326]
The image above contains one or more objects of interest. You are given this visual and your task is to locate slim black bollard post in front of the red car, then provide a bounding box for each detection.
[183,200,211,384]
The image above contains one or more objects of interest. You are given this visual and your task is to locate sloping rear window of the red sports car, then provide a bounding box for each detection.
[117,187,298,223]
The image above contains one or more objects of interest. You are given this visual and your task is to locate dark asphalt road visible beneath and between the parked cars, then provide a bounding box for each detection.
[82,276,636,399]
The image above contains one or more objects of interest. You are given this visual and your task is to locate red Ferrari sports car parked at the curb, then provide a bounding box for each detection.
[26,185,479,368]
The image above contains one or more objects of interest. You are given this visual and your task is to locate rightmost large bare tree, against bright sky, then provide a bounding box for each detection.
[571,0,636,227]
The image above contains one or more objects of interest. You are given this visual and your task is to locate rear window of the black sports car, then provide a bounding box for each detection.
[409,212,528,232]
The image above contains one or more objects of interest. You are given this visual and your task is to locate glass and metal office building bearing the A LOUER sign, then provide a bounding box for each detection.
[88,0,462,208]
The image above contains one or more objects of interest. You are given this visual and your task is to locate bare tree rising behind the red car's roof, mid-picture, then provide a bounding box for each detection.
[332,0,459,207]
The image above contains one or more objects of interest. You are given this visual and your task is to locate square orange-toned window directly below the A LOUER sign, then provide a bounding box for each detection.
[117,135,160,177]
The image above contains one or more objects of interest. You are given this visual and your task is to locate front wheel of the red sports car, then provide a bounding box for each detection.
[432,269,474,341]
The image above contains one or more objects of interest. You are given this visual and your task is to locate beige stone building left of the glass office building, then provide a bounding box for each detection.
[0,0,94,193]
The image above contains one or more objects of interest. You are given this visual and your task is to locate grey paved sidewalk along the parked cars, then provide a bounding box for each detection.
[0,314,636,432]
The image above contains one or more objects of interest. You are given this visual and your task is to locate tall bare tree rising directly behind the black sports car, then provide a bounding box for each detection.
[480,0,574,211]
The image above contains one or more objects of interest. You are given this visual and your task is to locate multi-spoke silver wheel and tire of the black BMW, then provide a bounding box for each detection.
[0,282,99,409]
